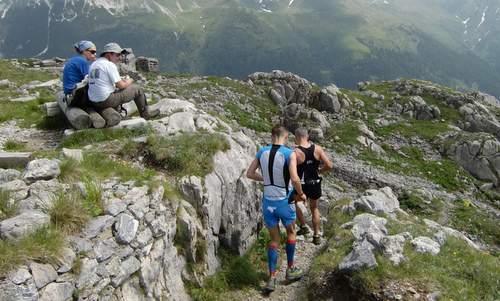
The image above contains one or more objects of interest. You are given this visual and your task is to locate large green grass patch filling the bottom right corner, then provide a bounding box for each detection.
[358,237,500,301]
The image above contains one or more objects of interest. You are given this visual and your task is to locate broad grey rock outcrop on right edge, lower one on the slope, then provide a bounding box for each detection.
[440,133,500,187]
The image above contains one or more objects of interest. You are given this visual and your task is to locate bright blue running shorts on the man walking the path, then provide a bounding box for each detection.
[262,198,297,228]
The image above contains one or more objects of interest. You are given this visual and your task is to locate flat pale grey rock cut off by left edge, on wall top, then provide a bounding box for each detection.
[0,211,50,239]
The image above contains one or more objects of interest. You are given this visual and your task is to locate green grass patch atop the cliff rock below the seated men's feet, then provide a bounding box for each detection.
[145,133,230,177]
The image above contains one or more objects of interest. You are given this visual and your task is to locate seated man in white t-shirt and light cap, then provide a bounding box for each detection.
[88,43,159,119]
